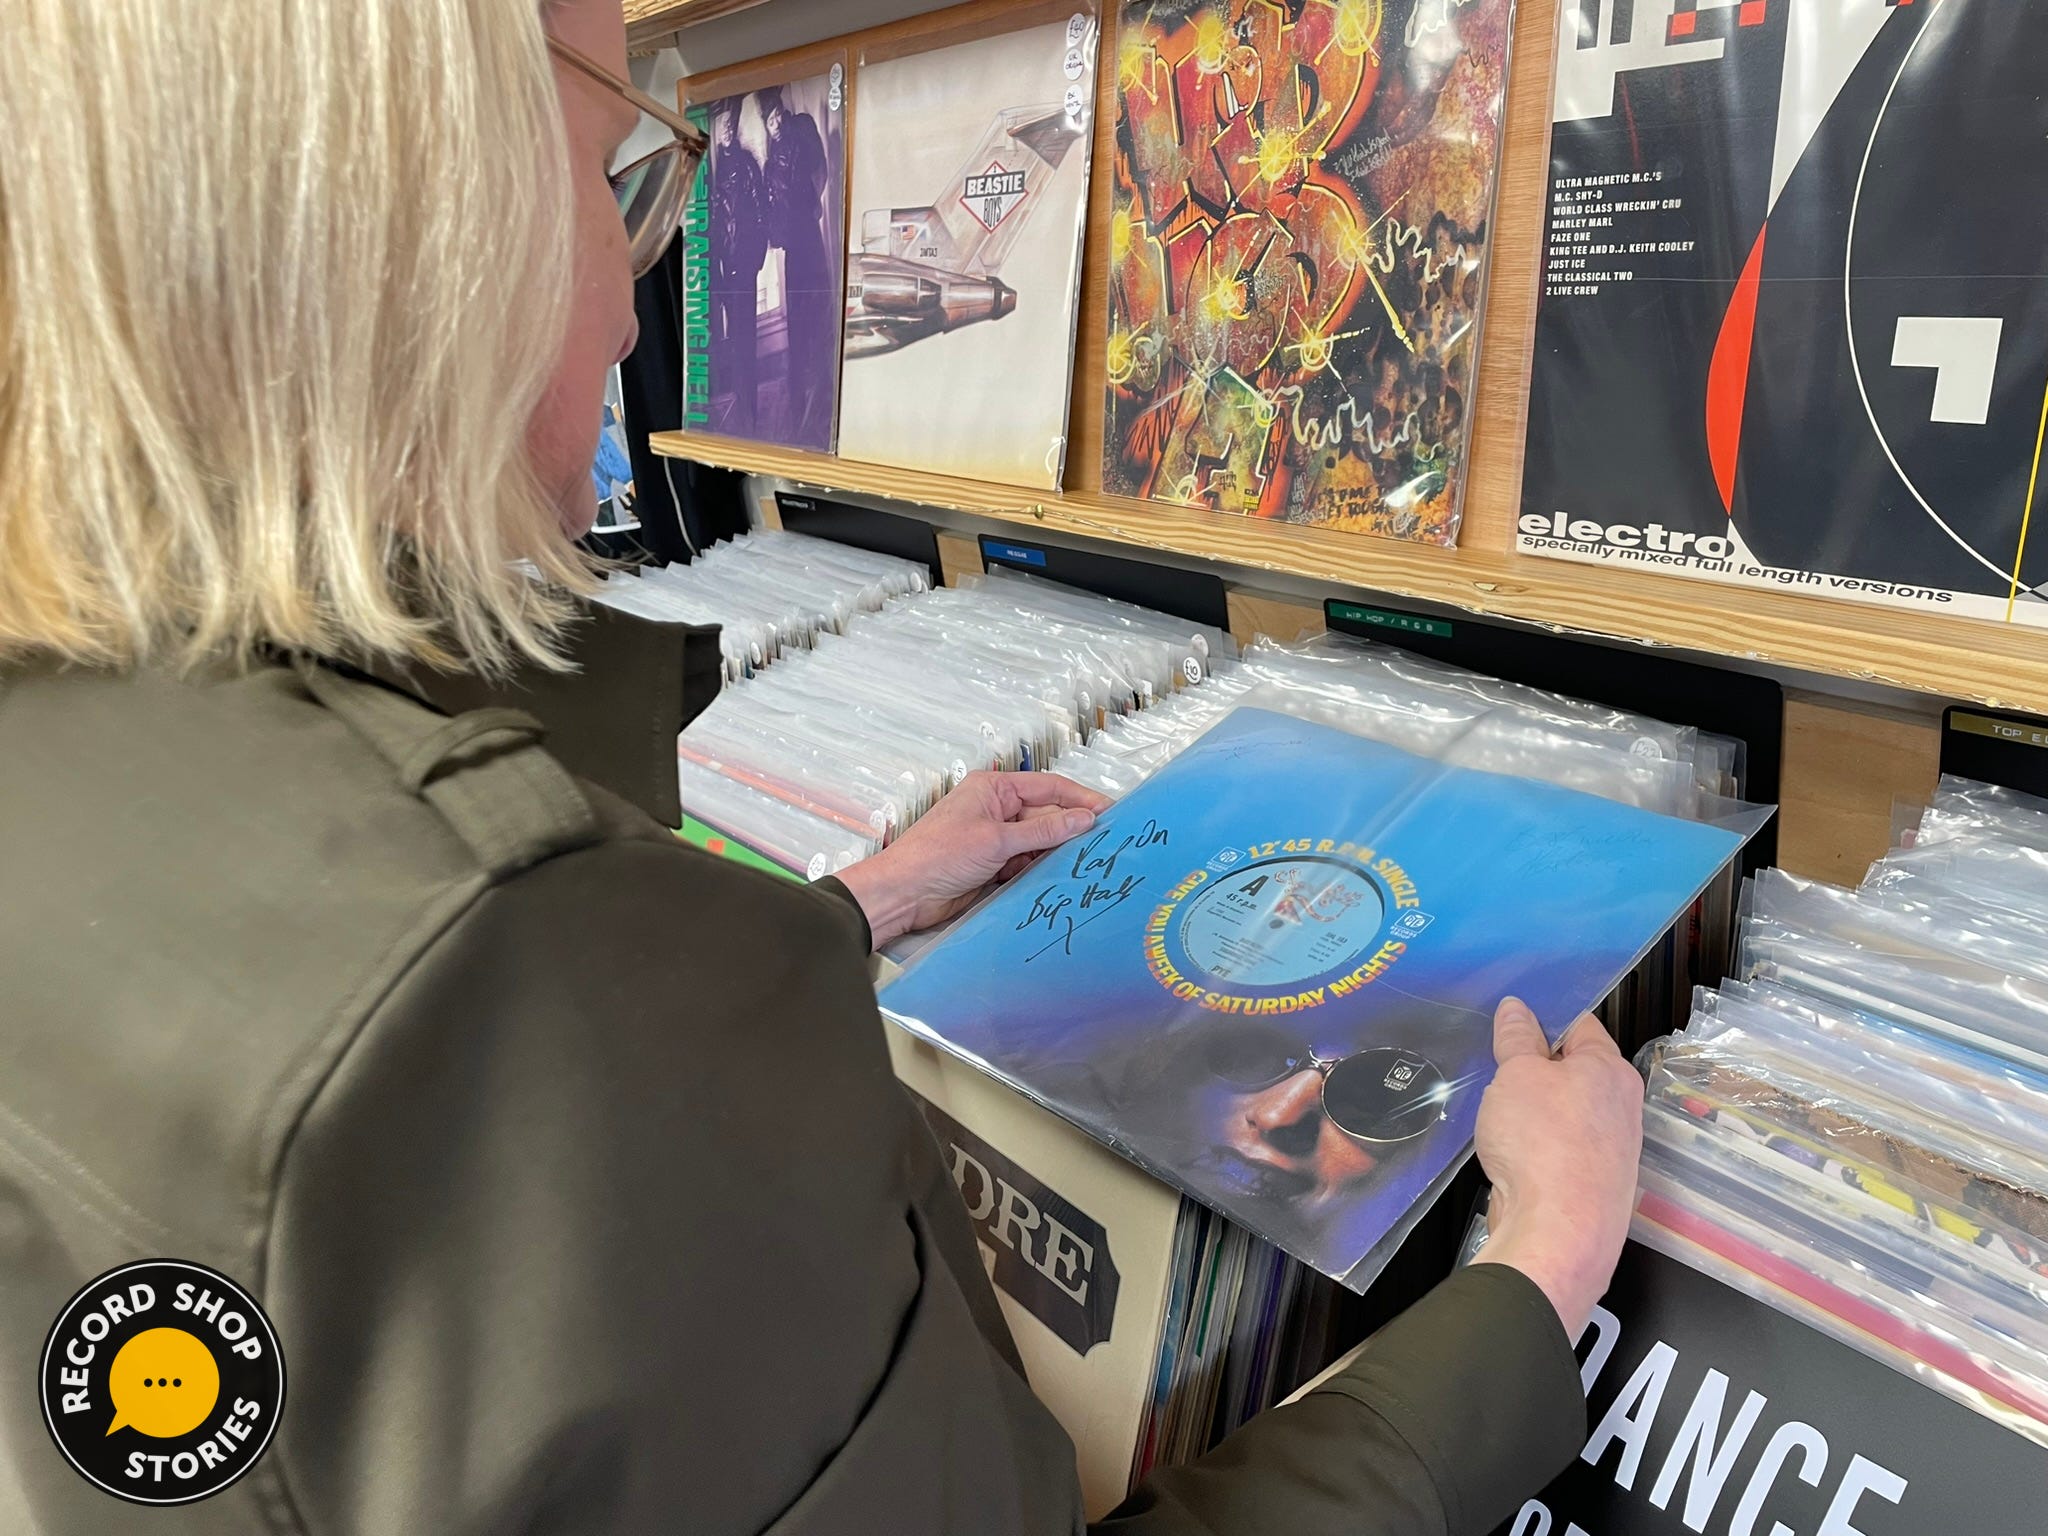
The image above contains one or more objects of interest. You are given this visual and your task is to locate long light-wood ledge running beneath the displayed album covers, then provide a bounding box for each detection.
[651,432,2048,713]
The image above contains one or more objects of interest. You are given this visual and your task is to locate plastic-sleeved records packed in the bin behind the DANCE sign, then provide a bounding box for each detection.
[1638,778,2048,1444]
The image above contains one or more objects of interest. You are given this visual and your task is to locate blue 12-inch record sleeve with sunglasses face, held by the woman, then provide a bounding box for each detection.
[881,707,1743,1288]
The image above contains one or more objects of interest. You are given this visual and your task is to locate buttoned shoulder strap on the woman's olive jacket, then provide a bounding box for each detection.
[297,659,600,879]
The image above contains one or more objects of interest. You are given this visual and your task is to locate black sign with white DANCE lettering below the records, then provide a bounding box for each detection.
[1497,1243,2048,1536]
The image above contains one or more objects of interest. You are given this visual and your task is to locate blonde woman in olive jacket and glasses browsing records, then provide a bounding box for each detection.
[0,0,1636,1536]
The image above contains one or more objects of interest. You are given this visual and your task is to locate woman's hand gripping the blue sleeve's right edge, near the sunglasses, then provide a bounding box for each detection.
[1479,997,1642,1343]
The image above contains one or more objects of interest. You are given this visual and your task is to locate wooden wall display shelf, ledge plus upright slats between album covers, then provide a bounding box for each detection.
[653,0,2048,713]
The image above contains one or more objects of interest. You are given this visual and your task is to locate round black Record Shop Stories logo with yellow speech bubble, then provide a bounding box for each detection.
[43,1260,285,1503]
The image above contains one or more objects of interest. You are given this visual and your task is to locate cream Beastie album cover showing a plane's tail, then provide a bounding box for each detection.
[840,10,1098,487]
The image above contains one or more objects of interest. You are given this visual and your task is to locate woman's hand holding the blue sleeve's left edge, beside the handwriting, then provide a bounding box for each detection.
[840,772,1110,948]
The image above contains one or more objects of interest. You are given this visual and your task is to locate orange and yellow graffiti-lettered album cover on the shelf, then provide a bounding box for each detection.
[1102,0,1513,545]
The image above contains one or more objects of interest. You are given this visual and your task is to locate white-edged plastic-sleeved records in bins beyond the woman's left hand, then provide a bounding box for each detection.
[630,535,1237,879]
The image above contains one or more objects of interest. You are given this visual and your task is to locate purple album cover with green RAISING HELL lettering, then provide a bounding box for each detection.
[684,63,846,453]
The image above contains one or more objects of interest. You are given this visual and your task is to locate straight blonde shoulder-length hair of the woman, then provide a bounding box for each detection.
[0,0,588,668]
